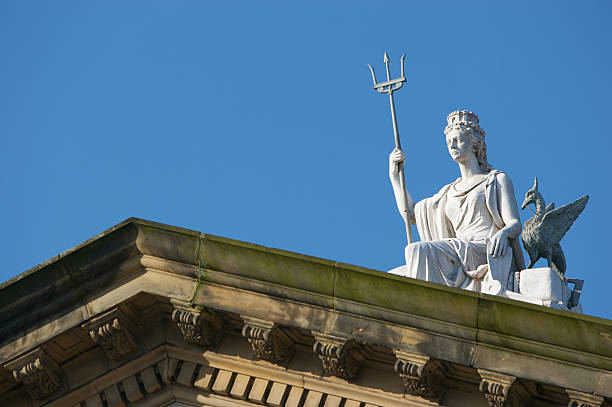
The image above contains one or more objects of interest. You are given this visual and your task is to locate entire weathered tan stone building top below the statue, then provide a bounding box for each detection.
[0,219,612,407]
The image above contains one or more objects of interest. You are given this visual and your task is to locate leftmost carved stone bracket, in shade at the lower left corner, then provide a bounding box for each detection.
[4,348,62,399]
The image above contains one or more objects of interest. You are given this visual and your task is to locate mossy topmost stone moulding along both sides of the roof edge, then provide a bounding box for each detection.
[0,218,612,371]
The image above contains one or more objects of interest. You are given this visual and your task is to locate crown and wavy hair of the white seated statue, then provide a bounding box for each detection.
[444,110,492,171]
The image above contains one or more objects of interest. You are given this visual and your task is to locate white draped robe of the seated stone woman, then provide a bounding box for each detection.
[392,170,525,289]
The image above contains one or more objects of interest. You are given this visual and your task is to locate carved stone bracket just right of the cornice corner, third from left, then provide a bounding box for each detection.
[171,300,221,348]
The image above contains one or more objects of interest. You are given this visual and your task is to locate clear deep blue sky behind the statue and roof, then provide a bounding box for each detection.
[0,0,612,319]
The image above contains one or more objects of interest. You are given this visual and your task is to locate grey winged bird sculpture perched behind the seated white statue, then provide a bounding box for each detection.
[521,177,589,276]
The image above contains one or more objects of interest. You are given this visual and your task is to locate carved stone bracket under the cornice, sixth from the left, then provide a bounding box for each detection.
[394,350,445,401]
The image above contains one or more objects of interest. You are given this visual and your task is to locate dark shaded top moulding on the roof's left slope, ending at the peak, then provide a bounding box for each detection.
[0,219,138,346]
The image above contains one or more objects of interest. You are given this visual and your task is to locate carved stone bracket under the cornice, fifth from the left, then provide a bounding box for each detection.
[312,331,364,379]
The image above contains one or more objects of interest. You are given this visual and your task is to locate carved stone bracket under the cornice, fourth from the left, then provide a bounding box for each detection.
[242,316,293,364]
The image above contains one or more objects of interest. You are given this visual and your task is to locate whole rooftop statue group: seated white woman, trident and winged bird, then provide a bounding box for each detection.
[368,52,588,312]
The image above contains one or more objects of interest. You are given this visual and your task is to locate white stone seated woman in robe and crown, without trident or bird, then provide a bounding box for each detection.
[389,110,525,294]
